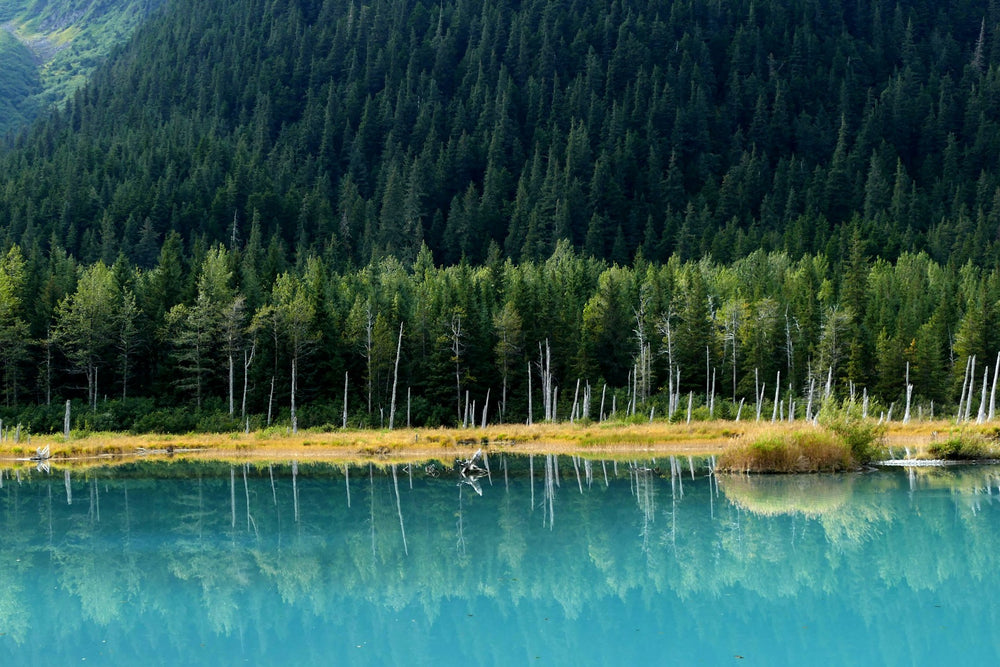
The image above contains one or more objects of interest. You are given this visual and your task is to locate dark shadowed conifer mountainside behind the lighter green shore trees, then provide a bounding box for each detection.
[0,0,1000,267]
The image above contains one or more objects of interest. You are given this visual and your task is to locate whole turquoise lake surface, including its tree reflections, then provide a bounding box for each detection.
[0,454,1000,666]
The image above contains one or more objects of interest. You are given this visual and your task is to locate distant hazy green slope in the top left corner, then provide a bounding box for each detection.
[0,0,161,137]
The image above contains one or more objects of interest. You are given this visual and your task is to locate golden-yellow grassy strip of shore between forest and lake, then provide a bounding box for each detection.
[0,421,968,467]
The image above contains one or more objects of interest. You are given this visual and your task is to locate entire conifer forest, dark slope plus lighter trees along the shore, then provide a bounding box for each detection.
[0,0,1000,430]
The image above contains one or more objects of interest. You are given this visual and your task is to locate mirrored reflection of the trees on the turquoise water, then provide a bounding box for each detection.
[0,455,1000,656]
